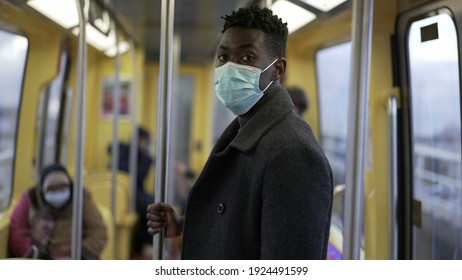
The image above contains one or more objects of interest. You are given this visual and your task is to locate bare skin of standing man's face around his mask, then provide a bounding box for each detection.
[215,27,275,89]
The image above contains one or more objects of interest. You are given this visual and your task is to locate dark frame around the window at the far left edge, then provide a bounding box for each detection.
[0,26,30,211]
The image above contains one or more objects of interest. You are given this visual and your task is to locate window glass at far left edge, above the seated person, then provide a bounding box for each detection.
[0,30,29,209]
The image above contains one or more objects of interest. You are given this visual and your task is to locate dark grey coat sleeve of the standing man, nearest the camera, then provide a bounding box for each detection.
[261,145,333,259]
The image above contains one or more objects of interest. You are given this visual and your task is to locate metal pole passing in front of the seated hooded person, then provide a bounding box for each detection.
[72,0,87,260]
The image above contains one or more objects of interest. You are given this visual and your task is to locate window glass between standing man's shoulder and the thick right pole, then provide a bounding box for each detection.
[316,42,351,228]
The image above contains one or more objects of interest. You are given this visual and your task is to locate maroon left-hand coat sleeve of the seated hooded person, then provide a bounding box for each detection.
[9,192,33,257]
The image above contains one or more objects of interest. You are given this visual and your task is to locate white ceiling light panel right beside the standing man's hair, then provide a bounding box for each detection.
[271,0,316,33]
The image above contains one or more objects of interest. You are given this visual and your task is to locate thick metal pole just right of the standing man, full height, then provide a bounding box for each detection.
[343,0,374,259]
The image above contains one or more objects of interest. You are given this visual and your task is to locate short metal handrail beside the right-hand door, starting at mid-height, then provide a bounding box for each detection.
[387,96,398,260]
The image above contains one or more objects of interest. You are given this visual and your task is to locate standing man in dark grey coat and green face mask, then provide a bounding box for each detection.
[147,7,332,259]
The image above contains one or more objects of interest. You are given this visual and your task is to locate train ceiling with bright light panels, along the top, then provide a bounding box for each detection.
[8,0,351,64]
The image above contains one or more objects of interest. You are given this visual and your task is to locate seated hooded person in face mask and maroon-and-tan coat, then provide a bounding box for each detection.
[9,164,107,259]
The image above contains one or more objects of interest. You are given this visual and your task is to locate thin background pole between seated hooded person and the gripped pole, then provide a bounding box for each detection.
[111,21,120,260]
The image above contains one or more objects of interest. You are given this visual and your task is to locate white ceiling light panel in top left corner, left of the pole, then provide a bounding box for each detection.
[27,0,79,29]
